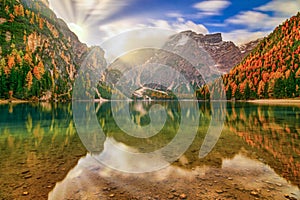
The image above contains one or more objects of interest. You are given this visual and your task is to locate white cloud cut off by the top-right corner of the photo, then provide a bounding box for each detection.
[255,0,300,17]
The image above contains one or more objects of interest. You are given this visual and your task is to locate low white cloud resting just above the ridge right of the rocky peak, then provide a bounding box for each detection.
[222,29,269,45]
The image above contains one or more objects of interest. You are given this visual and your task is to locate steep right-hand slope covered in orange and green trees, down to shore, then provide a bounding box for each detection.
[223,13,300,99]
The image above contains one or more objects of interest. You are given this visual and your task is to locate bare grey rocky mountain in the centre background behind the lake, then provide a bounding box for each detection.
[103,31,257,99]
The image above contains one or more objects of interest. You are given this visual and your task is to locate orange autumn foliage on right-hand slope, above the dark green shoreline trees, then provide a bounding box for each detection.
[223,13,300,98]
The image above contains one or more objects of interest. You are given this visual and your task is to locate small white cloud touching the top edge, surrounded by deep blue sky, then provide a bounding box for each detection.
[193,0,231,15]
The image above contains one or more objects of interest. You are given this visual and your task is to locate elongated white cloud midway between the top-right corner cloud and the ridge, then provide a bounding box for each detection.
[225,11,286,30]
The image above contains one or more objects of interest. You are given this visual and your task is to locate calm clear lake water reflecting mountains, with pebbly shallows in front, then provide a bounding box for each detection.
[0,101,300,199]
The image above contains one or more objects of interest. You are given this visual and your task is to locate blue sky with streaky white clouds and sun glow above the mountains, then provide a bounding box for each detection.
[49,0,300,46]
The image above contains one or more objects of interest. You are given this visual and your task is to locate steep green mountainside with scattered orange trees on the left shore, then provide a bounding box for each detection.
[0,0,88,100]
